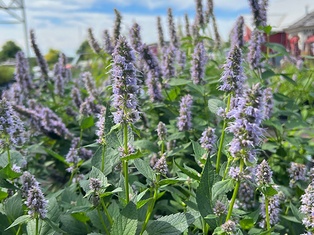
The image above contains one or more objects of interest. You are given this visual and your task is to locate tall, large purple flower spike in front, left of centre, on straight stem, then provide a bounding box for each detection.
[111,37,139,123]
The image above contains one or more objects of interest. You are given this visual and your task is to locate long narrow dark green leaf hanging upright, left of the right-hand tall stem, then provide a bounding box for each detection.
[196,158,217,228]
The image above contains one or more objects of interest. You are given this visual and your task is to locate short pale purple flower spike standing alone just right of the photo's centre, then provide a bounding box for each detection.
[177,94,193,131]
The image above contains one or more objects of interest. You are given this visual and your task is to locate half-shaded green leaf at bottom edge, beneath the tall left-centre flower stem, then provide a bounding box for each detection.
[110,202,138,235]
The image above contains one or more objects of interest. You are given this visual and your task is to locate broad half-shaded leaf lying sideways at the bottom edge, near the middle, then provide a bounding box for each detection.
[146,213,195,235]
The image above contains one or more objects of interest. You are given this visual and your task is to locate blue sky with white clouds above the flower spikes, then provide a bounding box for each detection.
[0,0,314,56]
